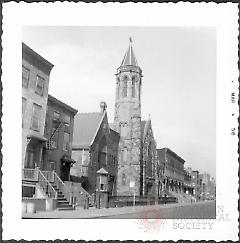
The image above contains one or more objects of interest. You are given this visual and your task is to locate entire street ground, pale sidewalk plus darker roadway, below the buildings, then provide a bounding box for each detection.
[22,201,216,219]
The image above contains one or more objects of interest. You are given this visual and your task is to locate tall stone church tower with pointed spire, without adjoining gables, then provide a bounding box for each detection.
[114,38,142,196]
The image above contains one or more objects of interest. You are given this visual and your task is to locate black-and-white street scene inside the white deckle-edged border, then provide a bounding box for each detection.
[22,26,216,218]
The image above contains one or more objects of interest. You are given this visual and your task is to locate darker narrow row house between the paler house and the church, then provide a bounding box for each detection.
[41,95,77,181]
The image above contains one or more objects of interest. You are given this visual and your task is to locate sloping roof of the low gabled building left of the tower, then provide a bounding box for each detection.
[73,112,106,148]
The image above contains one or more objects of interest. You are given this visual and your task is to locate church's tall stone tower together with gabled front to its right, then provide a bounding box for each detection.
[113,41,158,196]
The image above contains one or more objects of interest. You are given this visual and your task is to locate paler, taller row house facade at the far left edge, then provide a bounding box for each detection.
[22,43,53,168]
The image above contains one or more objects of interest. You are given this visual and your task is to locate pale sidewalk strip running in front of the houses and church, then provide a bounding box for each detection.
[22,202,210,219]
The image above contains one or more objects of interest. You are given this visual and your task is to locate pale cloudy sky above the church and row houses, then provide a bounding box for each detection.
[22,26,216,177]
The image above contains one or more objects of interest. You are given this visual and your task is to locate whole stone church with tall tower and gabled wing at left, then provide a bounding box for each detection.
[71,39,158,197]
